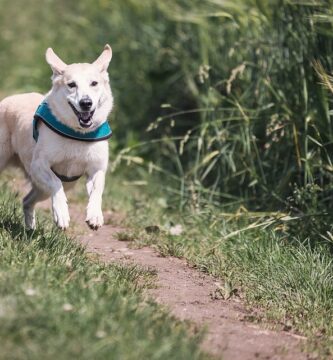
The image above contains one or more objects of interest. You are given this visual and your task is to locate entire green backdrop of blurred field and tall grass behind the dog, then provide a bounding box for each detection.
[0,0,333,219]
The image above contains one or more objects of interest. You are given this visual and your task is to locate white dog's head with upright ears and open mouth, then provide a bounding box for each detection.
[46,45,113,132]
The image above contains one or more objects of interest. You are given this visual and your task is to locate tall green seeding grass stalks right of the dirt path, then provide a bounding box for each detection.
[108,0,333,236]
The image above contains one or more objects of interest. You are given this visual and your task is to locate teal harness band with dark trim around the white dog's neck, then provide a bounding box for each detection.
[33,101,112,142]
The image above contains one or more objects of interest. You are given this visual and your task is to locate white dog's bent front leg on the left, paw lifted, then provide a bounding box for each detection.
[30,159,70,230]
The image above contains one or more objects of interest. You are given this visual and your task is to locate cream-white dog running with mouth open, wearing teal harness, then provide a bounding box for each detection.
[0,45,113,230]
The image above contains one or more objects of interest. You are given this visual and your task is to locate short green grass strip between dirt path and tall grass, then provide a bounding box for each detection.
[105,175,333,359]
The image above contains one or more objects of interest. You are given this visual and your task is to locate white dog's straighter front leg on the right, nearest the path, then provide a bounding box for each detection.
[86,170,105,230]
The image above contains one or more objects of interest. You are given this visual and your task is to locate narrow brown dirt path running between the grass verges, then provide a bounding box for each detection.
[73,215,307,360]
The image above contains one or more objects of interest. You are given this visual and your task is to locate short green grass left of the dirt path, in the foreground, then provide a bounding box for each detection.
[0,187,206,360]
